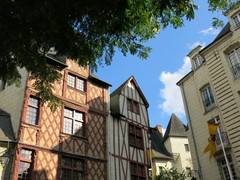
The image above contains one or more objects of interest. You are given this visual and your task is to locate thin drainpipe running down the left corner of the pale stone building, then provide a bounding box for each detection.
[180,84,203,180]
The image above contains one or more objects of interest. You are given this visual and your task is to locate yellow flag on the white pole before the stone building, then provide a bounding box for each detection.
[203,124,218,161]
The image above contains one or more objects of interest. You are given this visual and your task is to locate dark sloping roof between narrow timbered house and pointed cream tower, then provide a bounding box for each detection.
[150,128,172,159]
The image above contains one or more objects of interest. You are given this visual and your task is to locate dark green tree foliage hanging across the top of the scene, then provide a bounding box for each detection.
[0,0,237,108]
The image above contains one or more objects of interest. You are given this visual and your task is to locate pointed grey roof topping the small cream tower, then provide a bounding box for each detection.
[163,113,187,141]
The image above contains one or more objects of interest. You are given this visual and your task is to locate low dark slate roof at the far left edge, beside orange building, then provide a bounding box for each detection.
[0,109,15,141]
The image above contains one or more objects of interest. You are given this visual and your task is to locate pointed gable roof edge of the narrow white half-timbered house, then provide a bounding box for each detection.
[110,76,149,107]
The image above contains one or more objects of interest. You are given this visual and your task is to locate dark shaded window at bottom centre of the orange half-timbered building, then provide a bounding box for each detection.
[60,157,84,180]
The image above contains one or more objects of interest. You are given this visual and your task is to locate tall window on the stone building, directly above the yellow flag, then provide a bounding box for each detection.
[201,84,216,112]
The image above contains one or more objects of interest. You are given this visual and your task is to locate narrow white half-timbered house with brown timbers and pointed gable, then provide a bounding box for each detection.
[108,77,149,180]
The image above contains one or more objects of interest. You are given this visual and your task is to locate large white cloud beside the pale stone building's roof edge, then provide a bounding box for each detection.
[159,57,191,117]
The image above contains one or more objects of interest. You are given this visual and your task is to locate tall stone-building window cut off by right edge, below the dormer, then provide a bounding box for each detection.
[228,47,240,78]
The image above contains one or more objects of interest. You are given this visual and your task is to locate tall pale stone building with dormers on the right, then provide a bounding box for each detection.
[177,3,240,180]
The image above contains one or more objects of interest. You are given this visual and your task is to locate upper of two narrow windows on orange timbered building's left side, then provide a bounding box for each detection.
[26,96,39,125]
